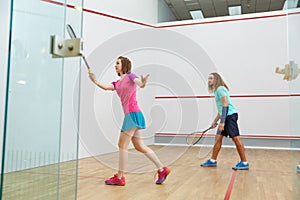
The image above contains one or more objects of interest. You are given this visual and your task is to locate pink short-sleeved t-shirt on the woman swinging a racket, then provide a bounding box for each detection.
[112,73,141,114]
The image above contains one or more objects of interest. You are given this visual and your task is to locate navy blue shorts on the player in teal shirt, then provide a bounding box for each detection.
[221,113,240,138]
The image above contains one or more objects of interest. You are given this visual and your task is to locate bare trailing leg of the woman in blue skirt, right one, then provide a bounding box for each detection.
[131,130,163,170]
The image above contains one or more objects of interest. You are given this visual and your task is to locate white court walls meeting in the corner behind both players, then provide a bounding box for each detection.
[80,8,298,157]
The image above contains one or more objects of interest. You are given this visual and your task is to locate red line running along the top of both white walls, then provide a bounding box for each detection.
[41,0,300,28]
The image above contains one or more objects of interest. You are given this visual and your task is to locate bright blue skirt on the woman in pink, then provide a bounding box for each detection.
[121,112,146,132]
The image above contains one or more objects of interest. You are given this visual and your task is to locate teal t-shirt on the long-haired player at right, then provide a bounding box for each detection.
[214,86,237,116]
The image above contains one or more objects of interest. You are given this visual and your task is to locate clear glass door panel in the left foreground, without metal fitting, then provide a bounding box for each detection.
[1,0,83,200]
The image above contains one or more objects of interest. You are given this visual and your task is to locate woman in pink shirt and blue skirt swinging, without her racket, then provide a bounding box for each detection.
[89,56,170,186]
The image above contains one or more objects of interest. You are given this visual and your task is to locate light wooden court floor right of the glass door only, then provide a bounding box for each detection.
[77,146,300,200]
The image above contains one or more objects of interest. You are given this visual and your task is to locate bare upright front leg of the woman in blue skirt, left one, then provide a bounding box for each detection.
[118,128,136,177]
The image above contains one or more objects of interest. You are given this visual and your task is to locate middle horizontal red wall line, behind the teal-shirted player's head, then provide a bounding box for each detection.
[155,94,300,99]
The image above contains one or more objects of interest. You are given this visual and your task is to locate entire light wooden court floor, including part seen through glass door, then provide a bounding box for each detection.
[2,146,300,200]
